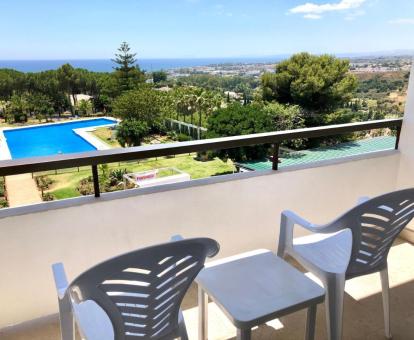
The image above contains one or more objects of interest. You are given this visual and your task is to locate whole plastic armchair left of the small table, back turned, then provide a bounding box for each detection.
[53,237,219,340]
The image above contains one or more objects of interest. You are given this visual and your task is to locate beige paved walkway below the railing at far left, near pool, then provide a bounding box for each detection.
[6,174,42,207]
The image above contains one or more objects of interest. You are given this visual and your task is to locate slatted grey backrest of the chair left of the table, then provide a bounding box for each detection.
[68,238,219,340]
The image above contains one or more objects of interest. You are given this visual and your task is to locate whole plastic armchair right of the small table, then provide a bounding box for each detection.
[278,189,414,340]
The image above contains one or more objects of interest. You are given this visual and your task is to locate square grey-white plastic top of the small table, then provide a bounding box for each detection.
[196,250,325,328]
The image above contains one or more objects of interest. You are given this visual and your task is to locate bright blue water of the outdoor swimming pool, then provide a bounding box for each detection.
[4,118,116,159]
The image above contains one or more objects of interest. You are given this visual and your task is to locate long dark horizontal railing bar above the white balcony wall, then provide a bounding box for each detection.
[0,118,402,176]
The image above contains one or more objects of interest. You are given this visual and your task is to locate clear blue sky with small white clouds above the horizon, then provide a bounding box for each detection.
[0,0,414,59]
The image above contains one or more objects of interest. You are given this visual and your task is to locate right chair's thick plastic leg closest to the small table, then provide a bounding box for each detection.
[325,275,345,340]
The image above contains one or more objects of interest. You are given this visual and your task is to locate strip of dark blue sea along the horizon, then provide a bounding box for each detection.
[0,56,287,72]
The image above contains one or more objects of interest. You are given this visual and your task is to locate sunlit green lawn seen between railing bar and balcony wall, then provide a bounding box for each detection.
[38,154,234,199]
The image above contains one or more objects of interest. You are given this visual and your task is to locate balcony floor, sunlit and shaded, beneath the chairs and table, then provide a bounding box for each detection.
[0,241,414,340]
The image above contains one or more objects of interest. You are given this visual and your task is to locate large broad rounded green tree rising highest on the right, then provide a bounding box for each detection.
[262,53,358,122]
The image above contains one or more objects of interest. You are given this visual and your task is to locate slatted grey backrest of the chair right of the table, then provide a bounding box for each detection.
[333,188,414,278]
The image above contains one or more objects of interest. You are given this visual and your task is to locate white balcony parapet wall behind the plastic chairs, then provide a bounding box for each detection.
[0,151,399,328]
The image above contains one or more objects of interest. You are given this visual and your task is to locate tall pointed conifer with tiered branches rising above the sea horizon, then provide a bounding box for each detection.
[112,42,145,92]
